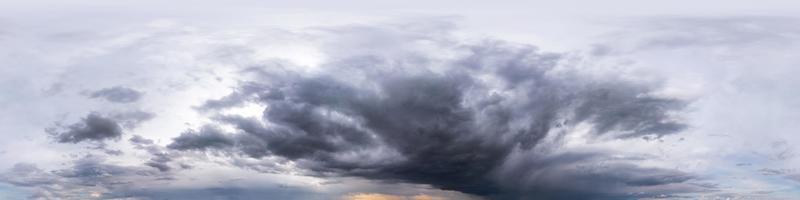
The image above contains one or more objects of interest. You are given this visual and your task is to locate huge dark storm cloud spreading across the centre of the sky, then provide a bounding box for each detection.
[169,28,692,199]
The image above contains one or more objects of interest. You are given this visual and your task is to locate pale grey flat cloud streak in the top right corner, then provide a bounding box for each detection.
[592,16,800,56]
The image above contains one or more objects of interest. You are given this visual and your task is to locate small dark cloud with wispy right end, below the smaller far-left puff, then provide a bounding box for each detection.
[45,110,155,143]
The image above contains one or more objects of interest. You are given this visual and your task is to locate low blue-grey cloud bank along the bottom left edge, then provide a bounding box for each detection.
[0,155,320,200]
